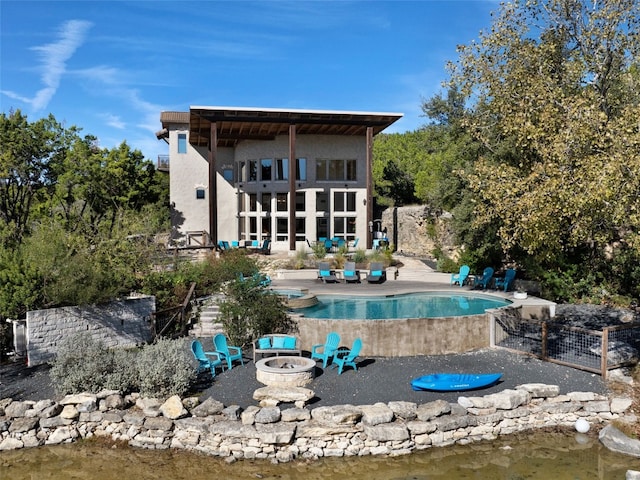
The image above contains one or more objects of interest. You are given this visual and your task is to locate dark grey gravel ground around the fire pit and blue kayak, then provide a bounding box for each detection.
[0,349,607,408]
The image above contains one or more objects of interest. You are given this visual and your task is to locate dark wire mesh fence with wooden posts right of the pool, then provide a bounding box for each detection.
[491,308,640,378]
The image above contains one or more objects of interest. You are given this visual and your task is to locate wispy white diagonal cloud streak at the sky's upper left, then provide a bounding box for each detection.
[28,20,92,111]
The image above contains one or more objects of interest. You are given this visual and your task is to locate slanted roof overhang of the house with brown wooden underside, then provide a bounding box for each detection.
[159,106,403,147]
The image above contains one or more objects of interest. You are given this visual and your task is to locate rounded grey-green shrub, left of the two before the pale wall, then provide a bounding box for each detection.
[50,333,113,395]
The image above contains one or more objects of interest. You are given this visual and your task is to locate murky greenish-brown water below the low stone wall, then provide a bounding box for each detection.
[0,432,640,480]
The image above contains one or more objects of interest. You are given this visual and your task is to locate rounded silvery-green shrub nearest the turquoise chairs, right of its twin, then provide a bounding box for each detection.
[136,338,197,398]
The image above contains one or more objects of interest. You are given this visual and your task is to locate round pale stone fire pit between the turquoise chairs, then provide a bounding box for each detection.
[256,356,316,387]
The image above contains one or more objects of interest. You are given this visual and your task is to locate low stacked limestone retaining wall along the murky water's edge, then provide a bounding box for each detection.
[0,384,631,462]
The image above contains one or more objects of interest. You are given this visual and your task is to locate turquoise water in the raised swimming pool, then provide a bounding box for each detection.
[300,292,511,320]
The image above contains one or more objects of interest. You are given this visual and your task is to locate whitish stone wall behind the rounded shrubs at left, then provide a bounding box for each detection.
[26,297,155,366]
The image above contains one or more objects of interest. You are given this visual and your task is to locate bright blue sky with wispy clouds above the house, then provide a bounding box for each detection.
[0,0,498,161]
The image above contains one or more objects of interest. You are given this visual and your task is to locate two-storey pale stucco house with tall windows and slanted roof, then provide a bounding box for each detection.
[156,106,402,252]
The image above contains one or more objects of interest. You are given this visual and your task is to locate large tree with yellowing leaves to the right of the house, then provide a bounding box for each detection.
[451,0,640,298]
